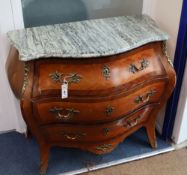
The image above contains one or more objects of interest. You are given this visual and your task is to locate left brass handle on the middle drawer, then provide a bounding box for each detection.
[49,107,80,120]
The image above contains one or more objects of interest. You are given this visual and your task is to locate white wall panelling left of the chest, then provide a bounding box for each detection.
[0,0,25,132]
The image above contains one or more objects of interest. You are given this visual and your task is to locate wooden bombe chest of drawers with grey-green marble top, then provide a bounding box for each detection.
[7,16,175,174]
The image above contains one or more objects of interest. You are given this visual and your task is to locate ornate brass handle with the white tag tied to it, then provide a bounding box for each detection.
[49,71,82,83]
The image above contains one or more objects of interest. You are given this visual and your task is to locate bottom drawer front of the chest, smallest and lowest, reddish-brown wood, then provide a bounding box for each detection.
[41,106,155,142]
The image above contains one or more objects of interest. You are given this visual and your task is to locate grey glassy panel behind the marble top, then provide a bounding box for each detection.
[22,0,143,27]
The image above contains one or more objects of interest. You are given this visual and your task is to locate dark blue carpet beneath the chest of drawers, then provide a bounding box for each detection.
[0,128,173,175]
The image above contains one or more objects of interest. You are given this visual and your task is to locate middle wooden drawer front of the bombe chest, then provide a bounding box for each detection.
[33,82,165,125]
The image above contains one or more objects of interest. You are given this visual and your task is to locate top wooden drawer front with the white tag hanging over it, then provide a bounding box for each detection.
[33,43,165,97]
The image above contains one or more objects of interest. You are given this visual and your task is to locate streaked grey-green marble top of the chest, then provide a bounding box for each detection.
[8,15,168,61]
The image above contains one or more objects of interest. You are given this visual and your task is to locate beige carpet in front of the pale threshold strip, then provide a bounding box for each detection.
[84,148,187,175]
